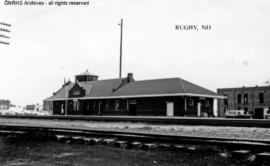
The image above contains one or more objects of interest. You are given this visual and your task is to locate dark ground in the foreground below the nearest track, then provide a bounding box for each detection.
[0,136,236,166]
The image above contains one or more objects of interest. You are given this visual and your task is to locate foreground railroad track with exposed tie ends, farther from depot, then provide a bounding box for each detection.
[0,125,270,150]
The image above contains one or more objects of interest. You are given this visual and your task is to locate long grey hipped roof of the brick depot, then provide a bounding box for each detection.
[47,78,223,100]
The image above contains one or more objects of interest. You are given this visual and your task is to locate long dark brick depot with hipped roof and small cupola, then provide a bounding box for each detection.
[44,71,224,116]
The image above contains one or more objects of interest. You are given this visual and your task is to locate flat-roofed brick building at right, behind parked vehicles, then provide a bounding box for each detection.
[217,86,270,119]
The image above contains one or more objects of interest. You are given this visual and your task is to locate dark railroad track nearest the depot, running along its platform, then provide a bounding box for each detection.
[0,115,270,128]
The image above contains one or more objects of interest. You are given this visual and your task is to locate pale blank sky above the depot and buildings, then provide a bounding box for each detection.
[0,0,270,106]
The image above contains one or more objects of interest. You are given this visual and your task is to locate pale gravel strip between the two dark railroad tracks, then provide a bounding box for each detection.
[0,118,270,141]
